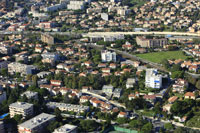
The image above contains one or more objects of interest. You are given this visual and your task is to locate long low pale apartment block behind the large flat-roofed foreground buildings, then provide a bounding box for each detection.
[46,102,89,112]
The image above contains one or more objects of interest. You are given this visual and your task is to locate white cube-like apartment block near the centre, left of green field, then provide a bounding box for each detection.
[101,50,117,62]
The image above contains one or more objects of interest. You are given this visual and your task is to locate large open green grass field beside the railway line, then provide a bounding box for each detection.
[136,51,187,63]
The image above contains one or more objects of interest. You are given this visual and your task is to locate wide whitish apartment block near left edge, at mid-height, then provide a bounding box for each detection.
[8,62,36,75]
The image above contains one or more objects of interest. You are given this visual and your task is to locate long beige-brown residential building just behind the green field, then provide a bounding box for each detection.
[136,36,168,48]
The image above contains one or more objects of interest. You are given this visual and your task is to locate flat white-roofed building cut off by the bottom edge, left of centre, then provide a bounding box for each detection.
[53,124,78,133]
